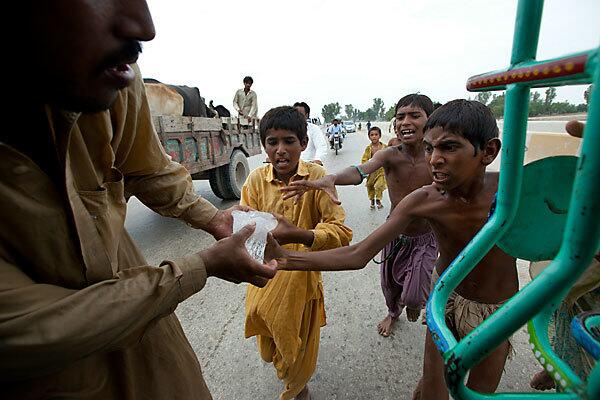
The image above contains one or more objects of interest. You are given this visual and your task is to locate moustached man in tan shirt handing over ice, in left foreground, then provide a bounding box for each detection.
[0,0,276,400]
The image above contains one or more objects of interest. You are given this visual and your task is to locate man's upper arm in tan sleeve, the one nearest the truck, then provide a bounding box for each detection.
[102,67,236,239]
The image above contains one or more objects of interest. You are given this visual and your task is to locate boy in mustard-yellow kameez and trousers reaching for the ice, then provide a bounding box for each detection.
[241,107,352,400]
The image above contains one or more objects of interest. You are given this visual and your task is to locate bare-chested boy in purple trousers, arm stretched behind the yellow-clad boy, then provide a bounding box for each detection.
[282,94,438,336]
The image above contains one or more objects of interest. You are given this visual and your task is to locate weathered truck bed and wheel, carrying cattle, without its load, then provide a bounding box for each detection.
[152,115,261,199]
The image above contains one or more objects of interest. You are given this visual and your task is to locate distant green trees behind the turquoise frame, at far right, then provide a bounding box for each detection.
[475,85,592,118]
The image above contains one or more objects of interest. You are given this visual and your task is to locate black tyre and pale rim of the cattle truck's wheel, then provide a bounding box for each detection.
[209,150,250,200]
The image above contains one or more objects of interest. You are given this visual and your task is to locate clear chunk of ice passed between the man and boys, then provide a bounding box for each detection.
[231,211,277,263]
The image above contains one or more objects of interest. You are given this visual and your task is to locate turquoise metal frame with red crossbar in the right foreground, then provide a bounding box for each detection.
[427,0,600,399]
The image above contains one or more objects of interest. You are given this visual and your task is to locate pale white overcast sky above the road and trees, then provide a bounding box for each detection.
[139,0,600,116]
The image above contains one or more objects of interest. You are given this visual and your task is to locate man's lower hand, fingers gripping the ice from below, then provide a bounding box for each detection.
[200,224,283,287]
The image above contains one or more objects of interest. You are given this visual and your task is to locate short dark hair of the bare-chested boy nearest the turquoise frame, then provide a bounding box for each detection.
[423,99,498,154]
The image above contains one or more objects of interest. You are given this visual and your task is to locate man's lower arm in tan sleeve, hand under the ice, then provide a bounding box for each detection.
[0,227,276,382]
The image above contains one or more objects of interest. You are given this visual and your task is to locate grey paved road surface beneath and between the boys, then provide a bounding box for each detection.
[126,123,538,400]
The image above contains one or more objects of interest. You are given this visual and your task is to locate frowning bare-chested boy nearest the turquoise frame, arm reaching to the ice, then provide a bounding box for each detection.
[270,100,518,399]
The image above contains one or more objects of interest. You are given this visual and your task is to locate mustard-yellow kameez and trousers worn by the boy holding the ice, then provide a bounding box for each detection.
[240,161,352,400]
